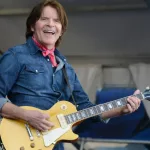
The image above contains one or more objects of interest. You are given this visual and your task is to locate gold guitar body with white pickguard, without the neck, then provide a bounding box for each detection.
[0,101,78,150]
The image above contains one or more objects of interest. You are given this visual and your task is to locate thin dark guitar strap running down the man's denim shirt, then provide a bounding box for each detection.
[62,65,78,108]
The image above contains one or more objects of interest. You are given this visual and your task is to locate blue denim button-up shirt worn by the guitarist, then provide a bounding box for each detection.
[0,37,103,150]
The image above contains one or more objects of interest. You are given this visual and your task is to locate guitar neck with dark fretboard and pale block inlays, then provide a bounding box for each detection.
[65,93,144,124]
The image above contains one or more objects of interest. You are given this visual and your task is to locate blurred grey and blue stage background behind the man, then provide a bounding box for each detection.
[0,0,150,150]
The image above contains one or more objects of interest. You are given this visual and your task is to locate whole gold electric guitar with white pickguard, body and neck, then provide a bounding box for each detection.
[0,89,150,150]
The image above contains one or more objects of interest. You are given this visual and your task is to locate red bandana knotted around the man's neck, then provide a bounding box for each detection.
[32,37,57,67]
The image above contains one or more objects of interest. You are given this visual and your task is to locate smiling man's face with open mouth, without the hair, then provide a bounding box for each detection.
[31,6,62,49]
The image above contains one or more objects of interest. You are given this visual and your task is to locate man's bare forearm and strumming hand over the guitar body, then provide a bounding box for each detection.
[0,102,54,132]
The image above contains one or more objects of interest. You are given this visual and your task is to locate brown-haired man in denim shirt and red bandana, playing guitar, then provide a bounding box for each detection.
[0,0,140,150]
